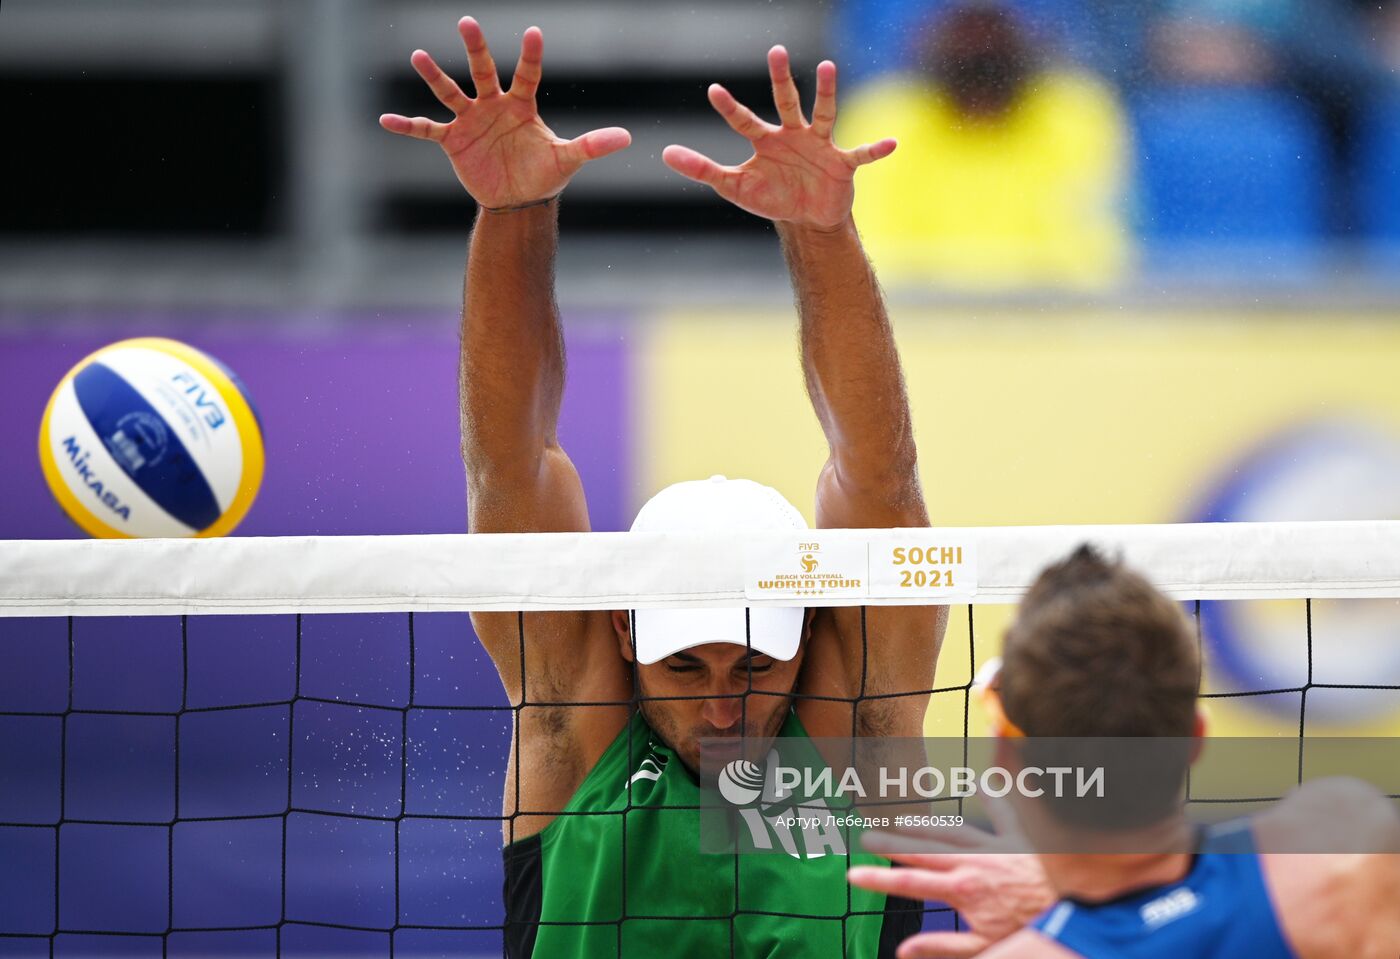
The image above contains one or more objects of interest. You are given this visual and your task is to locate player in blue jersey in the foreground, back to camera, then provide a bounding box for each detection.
[851,547,1400,959]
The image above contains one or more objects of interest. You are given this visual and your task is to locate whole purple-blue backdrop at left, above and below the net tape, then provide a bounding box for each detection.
[0,314,644,958]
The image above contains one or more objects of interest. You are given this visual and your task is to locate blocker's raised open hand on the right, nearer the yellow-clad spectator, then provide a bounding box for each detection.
[661,46,895,230]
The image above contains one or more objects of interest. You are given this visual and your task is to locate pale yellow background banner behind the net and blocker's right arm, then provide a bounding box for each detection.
[634,308,1400,736]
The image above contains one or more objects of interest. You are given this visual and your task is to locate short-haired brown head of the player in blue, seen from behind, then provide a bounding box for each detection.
[988,546,1204,851]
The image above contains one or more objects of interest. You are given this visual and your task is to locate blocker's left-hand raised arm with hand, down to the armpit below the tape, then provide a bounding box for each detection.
[379,17,630,840]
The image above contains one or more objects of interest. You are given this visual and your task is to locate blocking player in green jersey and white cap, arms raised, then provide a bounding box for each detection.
[381,18,946,956]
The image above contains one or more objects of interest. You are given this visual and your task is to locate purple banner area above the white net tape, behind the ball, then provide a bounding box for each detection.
[0,314,631,539]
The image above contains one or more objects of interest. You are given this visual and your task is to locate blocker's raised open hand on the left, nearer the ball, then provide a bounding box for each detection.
[379,17,631,210]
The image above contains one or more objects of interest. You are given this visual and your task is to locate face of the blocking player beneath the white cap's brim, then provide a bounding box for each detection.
[637,643,802,770]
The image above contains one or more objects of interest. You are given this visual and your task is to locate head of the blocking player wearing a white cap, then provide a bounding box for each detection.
[613,476,809,769]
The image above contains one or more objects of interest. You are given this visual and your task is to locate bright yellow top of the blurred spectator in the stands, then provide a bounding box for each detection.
[837,70,1131,288]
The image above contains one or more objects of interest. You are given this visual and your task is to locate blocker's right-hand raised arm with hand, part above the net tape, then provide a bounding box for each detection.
[664,46,928,526]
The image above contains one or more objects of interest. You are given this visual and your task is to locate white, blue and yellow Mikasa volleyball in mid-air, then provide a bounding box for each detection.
[39,337,263,539]
